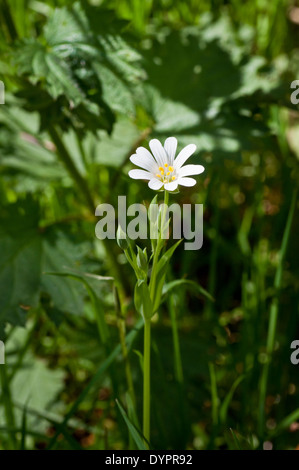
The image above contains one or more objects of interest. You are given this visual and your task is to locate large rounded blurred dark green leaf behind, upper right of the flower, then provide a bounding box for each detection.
[142,16,284,160]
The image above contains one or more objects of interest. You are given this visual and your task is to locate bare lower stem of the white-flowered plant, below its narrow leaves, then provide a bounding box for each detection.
[143,319,151,442]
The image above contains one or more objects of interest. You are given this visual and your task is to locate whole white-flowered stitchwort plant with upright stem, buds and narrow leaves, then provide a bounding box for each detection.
[117,137,204,443]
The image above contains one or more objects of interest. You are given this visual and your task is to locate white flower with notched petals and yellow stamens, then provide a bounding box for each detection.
[129,137,204,191]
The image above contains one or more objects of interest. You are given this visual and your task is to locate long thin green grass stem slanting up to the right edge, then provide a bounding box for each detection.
[258,190,297,437]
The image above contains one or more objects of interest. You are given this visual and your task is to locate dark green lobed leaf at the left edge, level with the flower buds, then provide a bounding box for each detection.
[0,197,97,329]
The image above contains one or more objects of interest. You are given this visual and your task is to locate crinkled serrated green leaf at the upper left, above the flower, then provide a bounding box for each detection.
[14,2,144,134]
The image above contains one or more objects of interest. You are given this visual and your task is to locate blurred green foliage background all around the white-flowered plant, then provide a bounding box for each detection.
[0,0,299,449]
